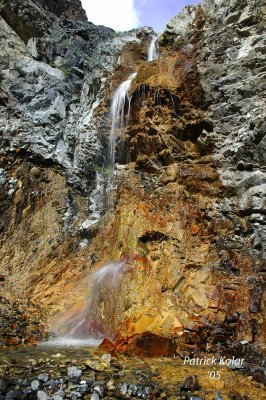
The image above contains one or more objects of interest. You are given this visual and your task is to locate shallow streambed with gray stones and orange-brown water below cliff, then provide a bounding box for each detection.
[0,345,266,400]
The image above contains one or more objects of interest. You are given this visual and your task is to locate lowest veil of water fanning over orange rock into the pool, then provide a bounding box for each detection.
[46,261,131,346]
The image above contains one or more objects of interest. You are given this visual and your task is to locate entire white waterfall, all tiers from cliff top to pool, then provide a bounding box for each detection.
[48,44,156,346]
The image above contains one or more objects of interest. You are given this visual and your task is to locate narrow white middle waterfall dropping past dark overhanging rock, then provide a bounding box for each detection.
[108,72,137,169]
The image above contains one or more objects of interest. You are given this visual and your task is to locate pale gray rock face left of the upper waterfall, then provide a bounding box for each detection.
[0,2,138,195]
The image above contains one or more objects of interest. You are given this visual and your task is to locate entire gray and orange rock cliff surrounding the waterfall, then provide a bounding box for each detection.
[0,0,266,381]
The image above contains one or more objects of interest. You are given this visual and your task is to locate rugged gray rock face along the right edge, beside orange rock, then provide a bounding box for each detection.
[199,0,266,255]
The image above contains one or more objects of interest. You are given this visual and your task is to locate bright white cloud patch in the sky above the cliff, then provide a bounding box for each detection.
[81,0,139,31]
